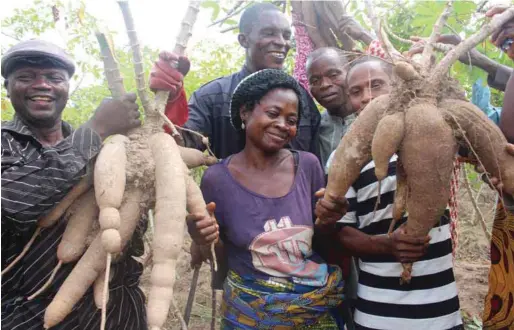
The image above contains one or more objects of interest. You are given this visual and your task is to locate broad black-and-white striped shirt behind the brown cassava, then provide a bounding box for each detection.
[330,155,462,330]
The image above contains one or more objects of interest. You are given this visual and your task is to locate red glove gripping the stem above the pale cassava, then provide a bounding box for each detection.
[149,51,191,127]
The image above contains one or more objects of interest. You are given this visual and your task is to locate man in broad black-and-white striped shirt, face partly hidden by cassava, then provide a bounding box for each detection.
[320,57,462,330]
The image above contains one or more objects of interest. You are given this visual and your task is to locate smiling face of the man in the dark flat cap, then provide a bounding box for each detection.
[7,66,69,127]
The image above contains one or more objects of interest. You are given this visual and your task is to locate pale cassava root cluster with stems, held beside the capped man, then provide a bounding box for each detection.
[40,1,208,329]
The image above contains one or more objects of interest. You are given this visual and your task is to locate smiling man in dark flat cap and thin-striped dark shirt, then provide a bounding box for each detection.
[1,40,146,330]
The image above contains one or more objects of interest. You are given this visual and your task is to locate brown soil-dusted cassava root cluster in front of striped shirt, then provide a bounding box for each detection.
[325,6,514,283]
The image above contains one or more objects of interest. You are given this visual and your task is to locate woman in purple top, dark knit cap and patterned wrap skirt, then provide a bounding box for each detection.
[188,69,343,329]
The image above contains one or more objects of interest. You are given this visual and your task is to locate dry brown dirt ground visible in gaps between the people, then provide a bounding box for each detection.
[141,171,495,330]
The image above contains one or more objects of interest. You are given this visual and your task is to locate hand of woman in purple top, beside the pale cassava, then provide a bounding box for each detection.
[186,202,219,246]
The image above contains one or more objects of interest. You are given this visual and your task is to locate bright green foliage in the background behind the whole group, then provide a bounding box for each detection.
[1,0,512,130]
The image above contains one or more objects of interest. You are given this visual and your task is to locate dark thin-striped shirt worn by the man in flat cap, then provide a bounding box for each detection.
[1,116,146,330]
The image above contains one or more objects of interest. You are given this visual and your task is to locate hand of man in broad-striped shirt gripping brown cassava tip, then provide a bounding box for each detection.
[389,224,431,263]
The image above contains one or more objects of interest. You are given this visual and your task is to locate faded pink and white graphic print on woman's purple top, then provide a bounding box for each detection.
[249,216,327,286]
